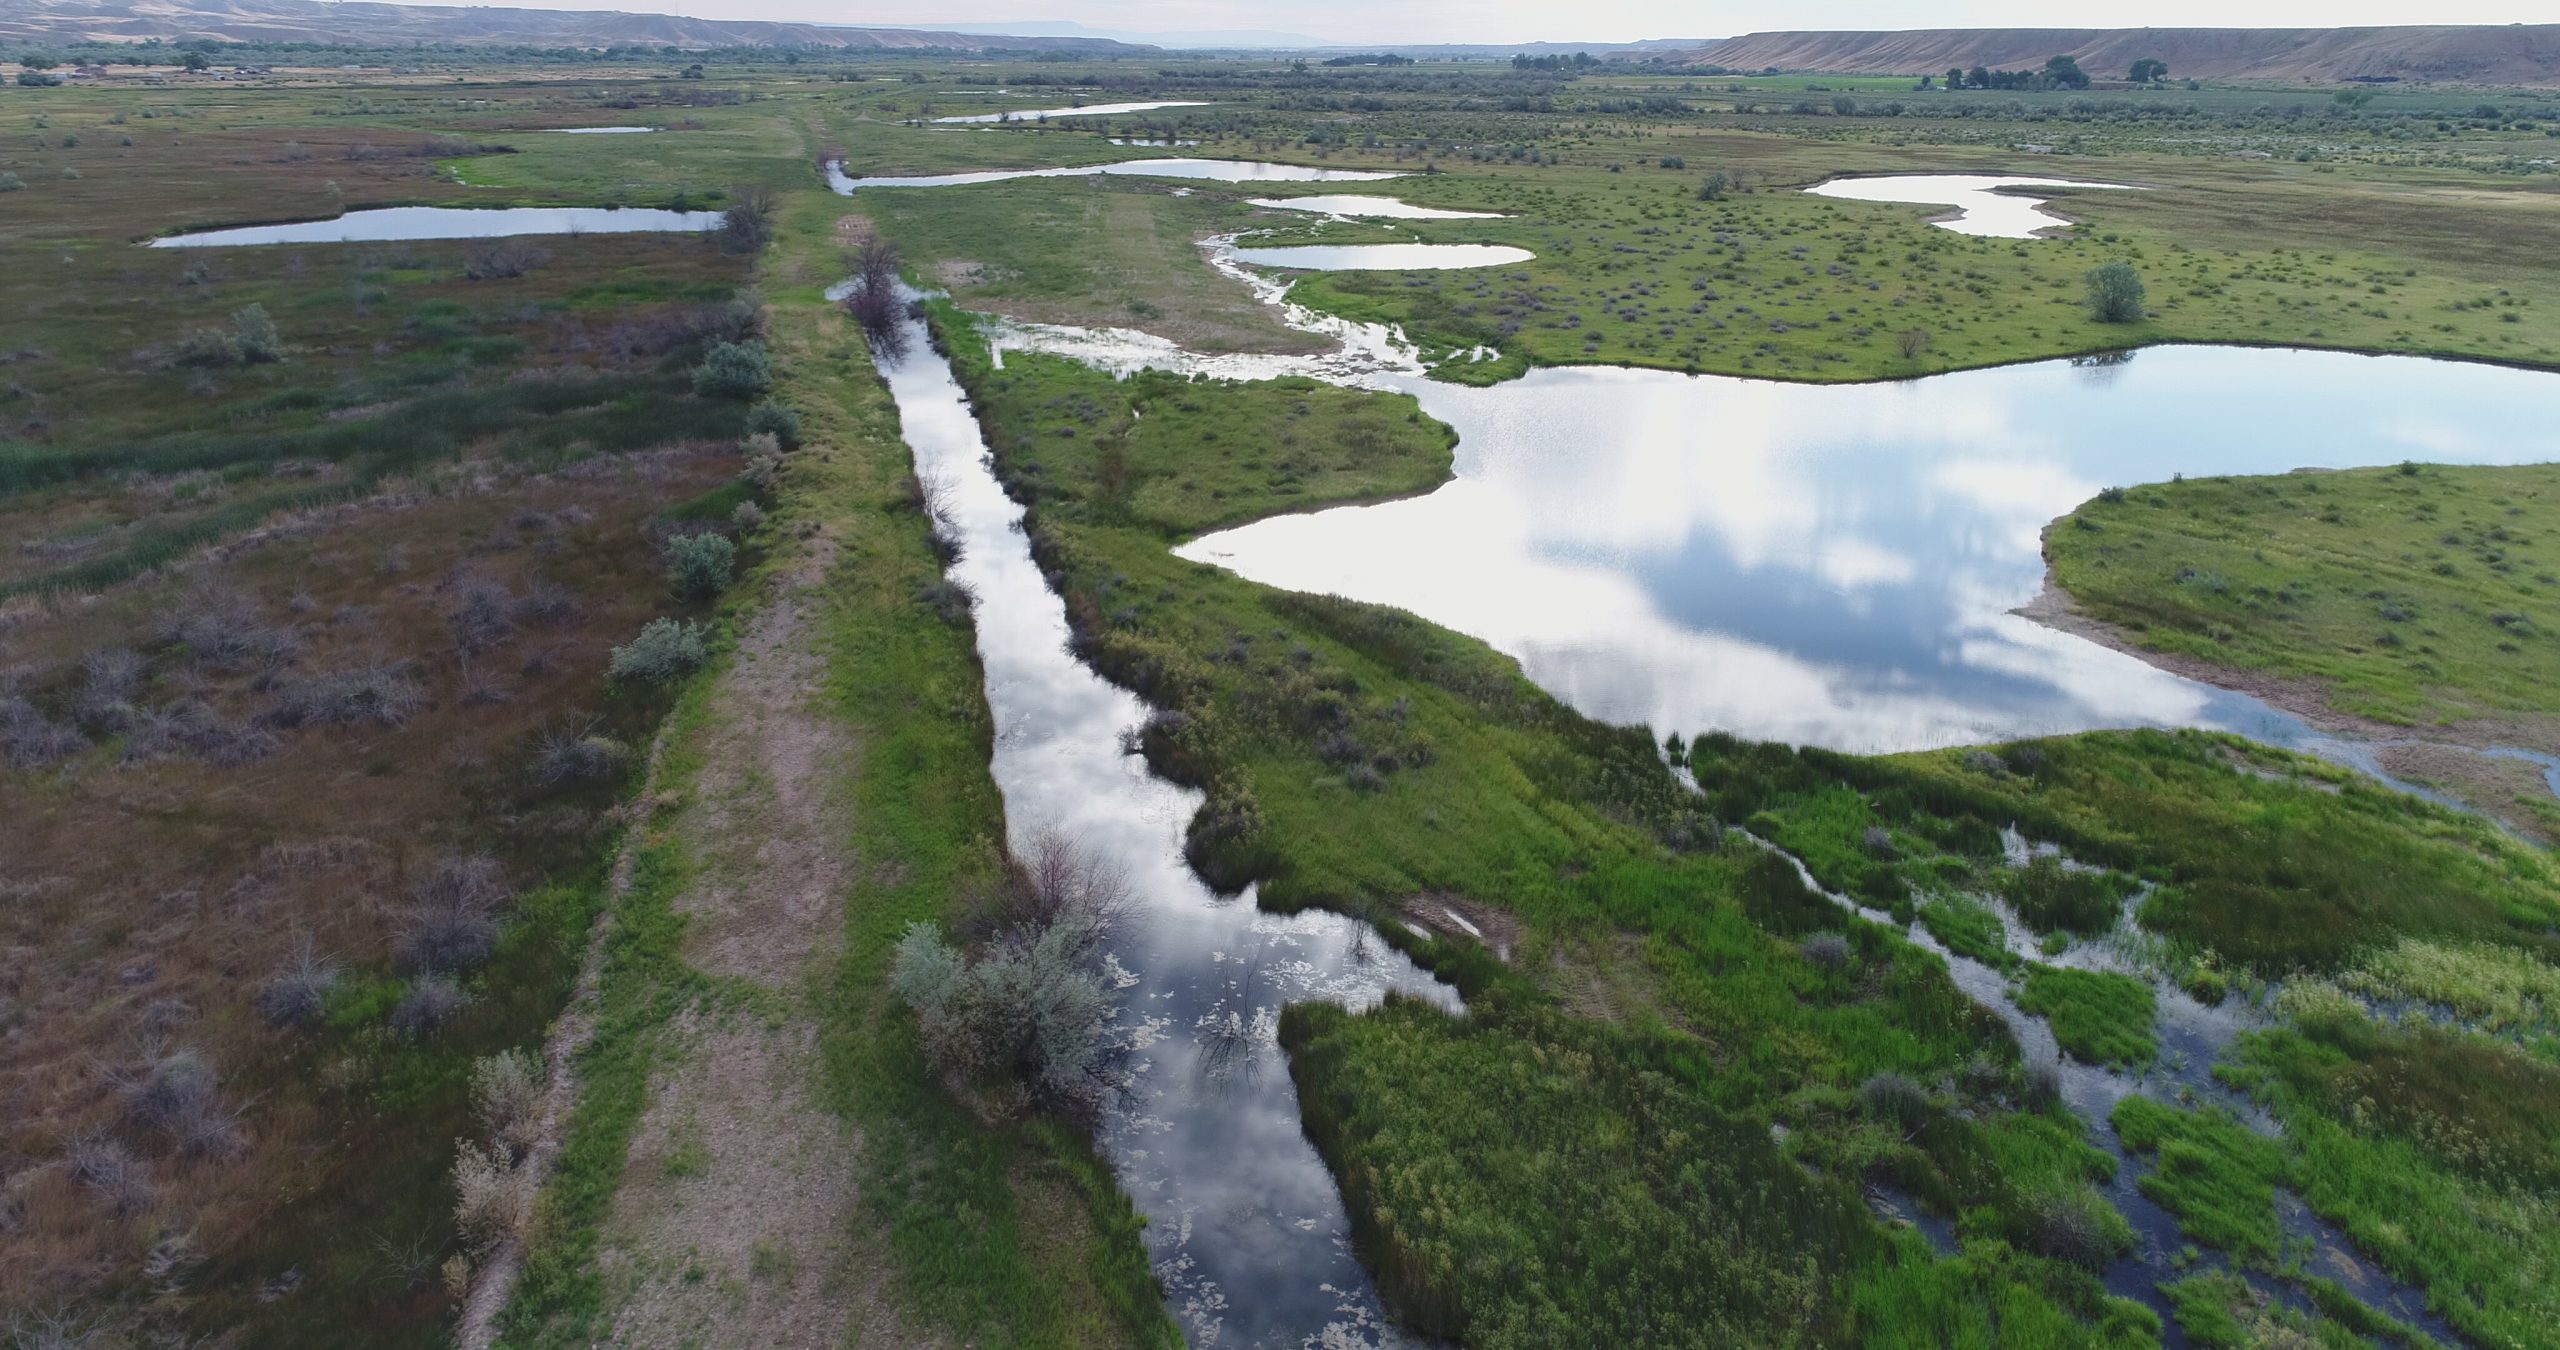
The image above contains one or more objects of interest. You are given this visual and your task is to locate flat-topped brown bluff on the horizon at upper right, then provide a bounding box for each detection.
[1682,23,2560,85]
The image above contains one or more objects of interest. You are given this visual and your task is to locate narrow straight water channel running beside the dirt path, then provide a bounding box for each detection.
[881,290,1457,1347]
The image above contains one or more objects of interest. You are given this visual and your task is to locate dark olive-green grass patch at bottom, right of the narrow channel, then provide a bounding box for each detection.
[1283,1002,1882,1347]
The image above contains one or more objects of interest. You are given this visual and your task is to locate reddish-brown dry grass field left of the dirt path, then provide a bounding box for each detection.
[0,448,737,1332]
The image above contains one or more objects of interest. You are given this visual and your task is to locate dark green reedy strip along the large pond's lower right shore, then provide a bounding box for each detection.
[1692,733,2560,976]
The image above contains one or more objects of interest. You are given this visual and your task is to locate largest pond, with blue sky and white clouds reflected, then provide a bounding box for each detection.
[1180,348,2560,753]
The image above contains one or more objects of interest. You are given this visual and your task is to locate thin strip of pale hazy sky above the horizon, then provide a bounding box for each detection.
[497,0,2555,44]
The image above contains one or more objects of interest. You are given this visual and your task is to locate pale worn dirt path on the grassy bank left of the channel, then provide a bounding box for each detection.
[578,538,934,1345]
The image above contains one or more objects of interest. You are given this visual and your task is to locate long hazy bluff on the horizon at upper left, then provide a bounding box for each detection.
[0,0,1155,56]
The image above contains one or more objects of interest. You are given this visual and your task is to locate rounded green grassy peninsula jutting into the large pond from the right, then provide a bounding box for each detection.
[2045,464,2560,748]
